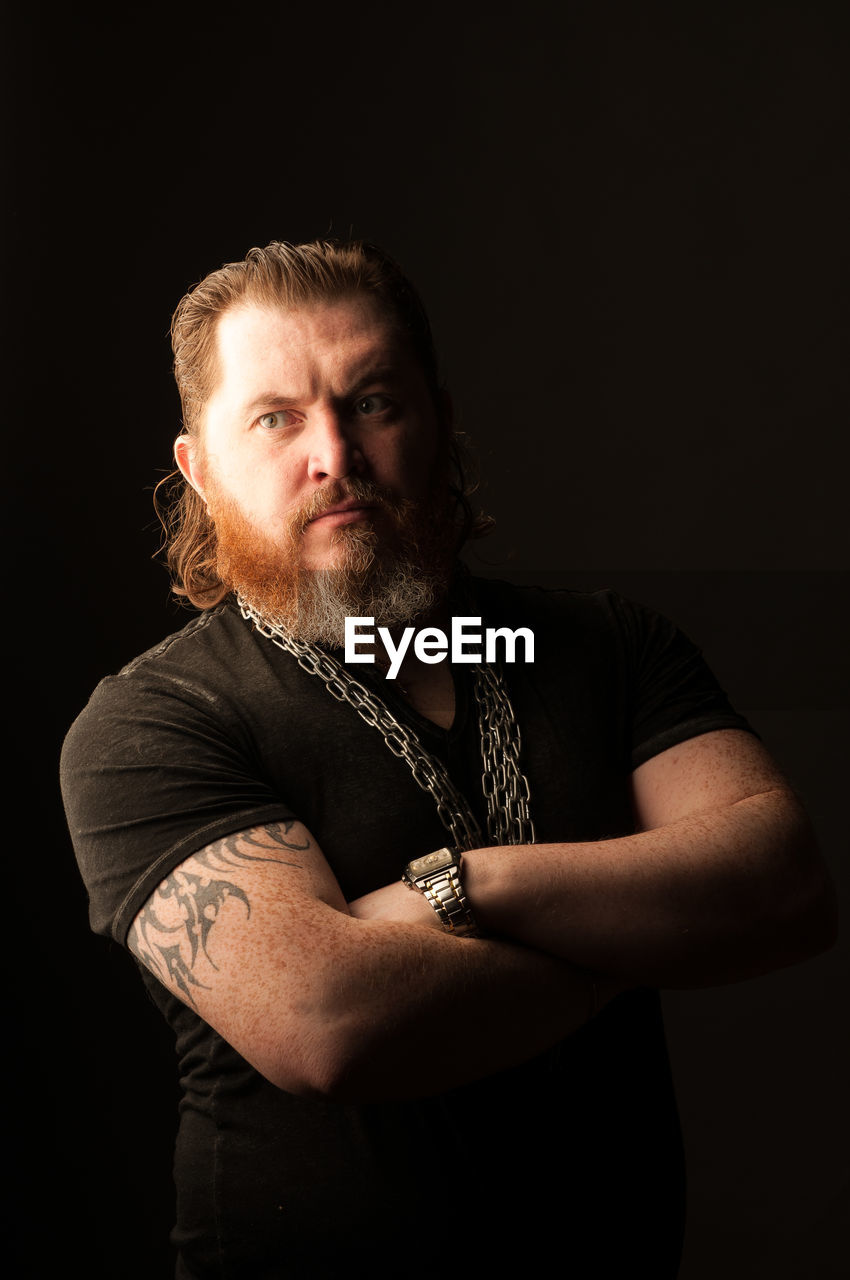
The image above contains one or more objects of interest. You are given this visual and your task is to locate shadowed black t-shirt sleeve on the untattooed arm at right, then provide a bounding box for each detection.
[609,595,754,769]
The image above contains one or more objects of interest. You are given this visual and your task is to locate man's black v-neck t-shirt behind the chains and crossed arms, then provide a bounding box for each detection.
[63,581,748,1280]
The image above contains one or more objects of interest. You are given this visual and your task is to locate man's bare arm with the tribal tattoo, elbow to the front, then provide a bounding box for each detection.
[128,823,604,1101]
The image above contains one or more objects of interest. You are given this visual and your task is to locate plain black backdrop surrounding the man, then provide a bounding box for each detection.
[3,0,850,1280]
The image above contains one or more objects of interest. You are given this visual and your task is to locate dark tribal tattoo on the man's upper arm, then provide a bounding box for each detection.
[128,820,310,1005]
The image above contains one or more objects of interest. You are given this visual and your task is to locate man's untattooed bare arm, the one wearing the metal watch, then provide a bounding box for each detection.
[352,730,835,987]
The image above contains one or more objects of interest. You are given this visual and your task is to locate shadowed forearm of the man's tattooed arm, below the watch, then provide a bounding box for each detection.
[305,908,612,1101]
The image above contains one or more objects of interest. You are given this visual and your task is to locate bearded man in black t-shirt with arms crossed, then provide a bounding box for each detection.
[63,243,832,1280]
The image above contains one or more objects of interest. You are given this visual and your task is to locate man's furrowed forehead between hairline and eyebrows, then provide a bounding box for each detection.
[208,297,415,399]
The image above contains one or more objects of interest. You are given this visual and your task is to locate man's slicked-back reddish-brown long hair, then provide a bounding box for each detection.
[154,241,494,609]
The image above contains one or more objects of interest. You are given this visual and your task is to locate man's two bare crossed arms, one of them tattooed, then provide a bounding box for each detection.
[128,730,835,1101]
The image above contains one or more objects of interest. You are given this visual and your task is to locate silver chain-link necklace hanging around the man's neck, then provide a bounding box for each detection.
[238,596,535,851]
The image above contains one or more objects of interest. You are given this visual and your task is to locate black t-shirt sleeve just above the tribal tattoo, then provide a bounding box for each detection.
[60,672,294,943]
